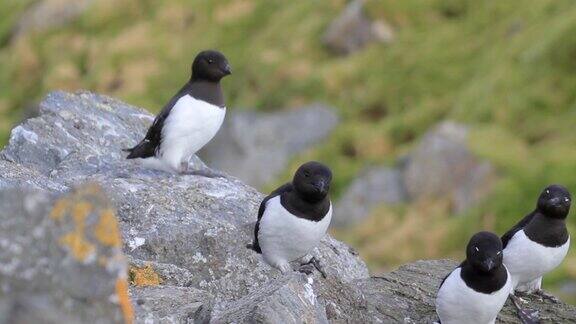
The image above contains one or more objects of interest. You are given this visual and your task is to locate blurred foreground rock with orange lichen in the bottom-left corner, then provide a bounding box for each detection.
[0,186,132,323]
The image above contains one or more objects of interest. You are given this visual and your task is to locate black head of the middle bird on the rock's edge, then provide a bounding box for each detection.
[292,161,332,202]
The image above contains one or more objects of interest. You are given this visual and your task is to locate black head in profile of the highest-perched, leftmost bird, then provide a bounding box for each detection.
[192,50,232,82]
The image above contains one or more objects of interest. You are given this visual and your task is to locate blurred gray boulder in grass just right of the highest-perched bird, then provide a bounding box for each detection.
[200,104,338,187]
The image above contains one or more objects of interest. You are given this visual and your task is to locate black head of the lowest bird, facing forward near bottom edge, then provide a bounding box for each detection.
[466,232,502,273]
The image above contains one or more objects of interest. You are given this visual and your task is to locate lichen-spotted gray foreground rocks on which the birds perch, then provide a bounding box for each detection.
[0,92,576,323]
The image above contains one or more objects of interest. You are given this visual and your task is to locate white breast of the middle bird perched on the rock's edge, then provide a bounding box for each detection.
[258,196,332,264]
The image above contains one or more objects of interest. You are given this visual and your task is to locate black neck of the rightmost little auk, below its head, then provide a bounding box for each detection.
[524,211,569,247]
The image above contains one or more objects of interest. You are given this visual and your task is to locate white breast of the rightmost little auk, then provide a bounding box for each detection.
[504,230,570,287]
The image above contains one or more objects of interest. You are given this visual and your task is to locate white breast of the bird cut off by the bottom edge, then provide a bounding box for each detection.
[436,268,512,324]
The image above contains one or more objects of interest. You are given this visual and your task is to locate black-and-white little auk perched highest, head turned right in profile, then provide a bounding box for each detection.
[126,50,231,174]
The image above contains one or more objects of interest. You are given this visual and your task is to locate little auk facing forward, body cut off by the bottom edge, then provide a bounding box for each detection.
[436,232,512,324]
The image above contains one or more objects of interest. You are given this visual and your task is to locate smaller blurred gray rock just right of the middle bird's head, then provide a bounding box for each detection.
[333,167,407,226]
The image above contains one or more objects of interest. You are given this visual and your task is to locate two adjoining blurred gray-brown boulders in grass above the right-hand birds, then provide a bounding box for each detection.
[334,121,496,226]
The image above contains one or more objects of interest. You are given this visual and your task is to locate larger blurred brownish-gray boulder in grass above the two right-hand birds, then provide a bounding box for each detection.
[404,122,495,213]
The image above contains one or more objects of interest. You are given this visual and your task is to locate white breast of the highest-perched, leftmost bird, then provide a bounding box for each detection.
[160,95,226,169]
